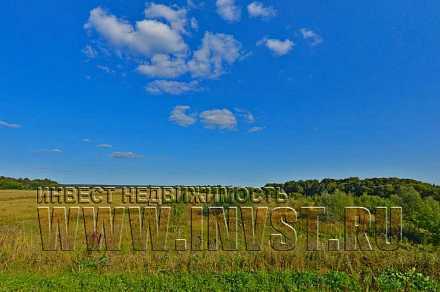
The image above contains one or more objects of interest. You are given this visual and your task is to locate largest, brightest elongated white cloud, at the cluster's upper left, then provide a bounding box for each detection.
[84,7,187,56]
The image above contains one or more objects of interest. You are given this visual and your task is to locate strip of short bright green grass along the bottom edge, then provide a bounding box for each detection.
[0,270,439,291]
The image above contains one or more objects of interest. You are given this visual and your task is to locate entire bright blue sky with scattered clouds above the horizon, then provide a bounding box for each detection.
[0,0,440,185]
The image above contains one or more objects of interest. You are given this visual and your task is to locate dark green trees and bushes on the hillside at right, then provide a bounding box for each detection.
[268,178,440,245]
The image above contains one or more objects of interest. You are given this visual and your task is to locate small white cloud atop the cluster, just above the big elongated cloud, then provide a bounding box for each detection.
[145,3,187,33]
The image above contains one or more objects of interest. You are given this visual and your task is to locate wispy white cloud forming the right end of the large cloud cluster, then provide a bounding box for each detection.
[188,32,241,78]
